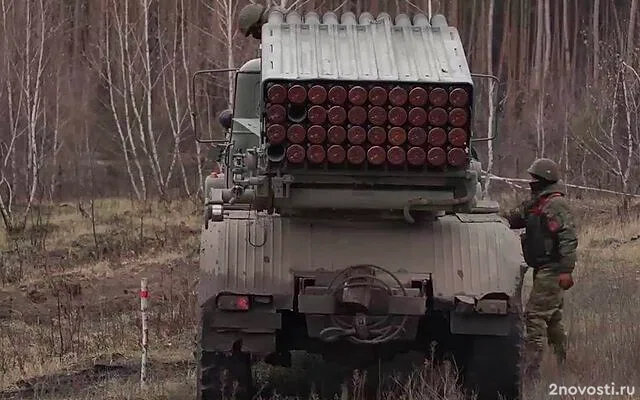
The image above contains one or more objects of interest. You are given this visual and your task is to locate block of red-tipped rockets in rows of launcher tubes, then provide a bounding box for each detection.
[264,82,472,171]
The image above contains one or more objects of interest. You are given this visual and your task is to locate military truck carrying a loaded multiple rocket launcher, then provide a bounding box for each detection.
[194,4,524,400]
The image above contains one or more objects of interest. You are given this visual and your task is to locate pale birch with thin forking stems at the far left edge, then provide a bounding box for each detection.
[0,0,57,232]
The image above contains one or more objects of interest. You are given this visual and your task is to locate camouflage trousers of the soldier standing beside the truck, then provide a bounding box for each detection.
[525,267,567,378]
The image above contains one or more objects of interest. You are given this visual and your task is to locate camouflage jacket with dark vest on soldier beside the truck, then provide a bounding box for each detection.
[505,184,578,273]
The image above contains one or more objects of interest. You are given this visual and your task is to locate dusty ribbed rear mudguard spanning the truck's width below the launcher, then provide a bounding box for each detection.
[198,210,525,348]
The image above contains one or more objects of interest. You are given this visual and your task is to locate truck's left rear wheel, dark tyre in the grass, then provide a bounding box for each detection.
[197,351,253,400]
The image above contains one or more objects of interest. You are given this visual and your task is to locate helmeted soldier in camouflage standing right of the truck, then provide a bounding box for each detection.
[506,158,578,379]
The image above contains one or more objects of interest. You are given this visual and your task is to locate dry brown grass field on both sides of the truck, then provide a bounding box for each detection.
[0,194,640,400]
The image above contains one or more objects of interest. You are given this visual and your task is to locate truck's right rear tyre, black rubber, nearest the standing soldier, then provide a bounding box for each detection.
[458,317,523,400]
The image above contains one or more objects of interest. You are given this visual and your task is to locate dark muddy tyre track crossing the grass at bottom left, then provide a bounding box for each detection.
[0,361,196,400]
